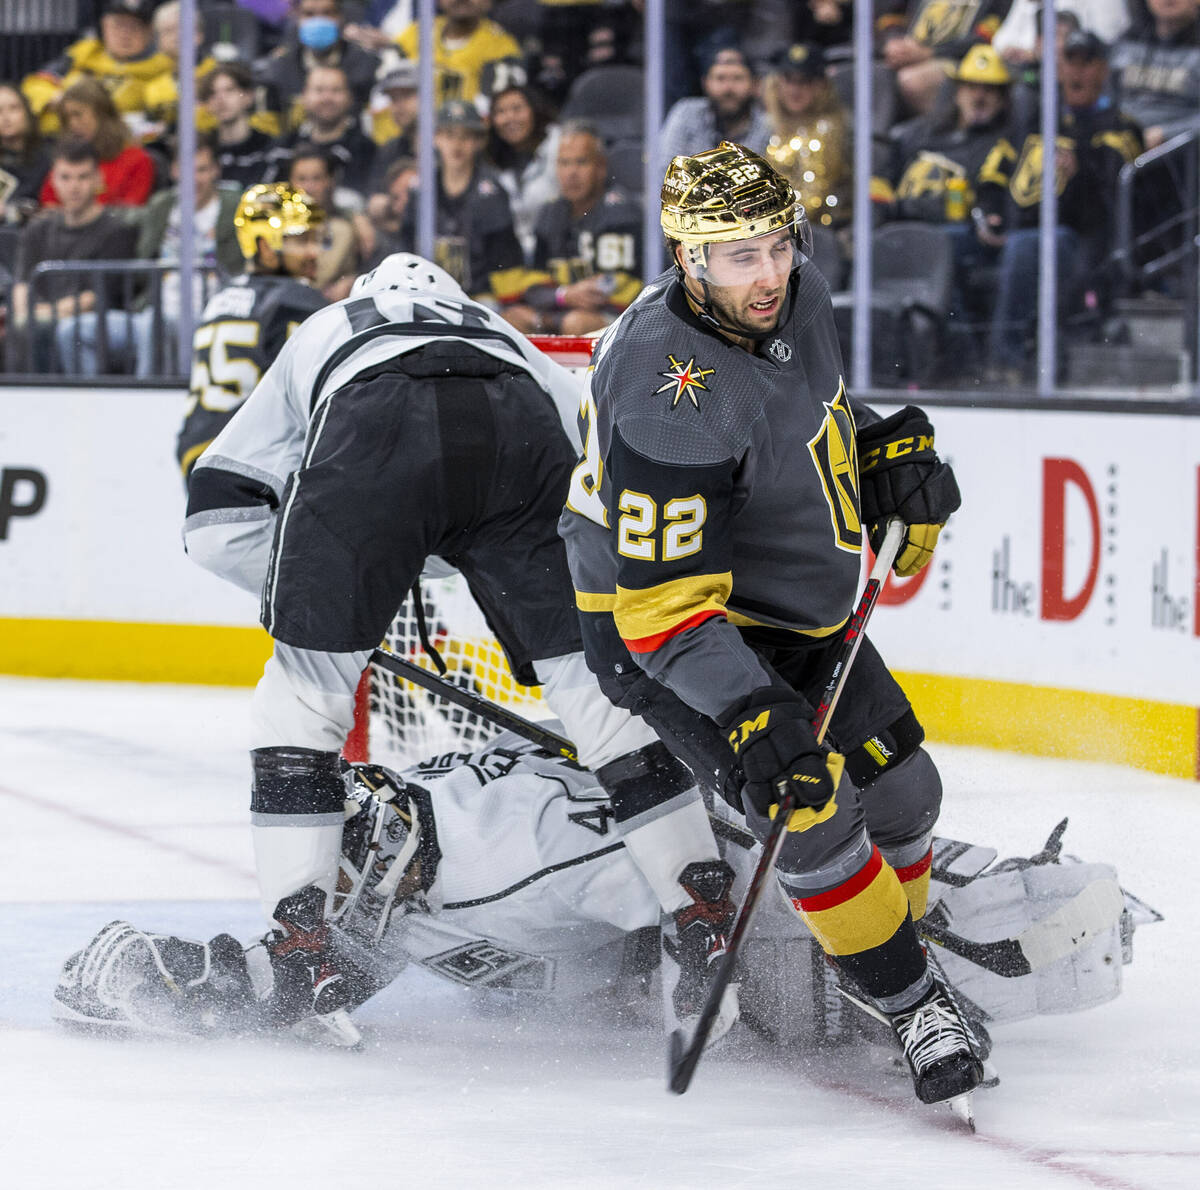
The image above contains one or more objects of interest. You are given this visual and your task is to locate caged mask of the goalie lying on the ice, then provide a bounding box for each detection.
[331,764,436,942]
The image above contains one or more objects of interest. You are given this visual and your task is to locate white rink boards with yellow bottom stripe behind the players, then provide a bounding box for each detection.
[0,387,1200,777]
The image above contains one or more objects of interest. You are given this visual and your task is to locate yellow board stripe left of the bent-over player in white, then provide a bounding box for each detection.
[0,619,271,686]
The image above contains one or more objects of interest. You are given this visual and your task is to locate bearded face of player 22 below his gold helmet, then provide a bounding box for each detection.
[685,230,799,335]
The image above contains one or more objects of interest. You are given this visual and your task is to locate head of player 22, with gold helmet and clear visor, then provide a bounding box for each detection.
[660,140,812,341]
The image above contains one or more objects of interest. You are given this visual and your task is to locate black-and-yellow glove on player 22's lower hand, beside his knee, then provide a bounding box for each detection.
[721,686,845,830]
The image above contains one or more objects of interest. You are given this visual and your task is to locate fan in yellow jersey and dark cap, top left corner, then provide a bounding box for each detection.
[20,0,174,132]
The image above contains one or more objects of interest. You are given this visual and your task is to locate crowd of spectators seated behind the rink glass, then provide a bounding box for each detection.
[0,0,1200,381]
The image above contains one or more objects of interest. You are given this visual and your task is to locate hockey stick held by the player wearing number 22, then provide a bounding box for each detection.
[667,519,905,1095]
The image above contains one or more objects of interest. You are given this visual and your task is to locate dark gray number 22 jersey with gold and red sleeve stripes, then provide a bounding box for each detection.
[560,265,876,719]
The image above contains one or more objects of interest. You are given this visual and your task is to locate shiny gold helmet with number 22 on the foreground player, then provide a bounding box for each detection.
[660,140,803,246]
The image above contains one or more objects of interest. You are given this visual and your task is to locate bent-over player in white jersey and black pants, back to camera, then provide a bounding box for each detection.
[185,254,732,1029]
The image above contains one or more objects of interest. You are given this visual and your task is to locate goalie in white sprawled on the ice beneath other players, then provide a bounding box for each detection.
[55,737,1157,1046]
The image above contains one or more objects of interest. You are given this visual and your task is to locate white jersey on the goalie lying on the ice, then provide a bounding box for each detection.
[343,735,661,994]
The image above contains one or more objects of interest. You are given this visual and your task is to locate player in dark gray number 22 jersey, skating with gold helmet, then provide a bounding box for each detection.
[562,143,982,1101]
